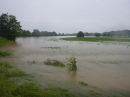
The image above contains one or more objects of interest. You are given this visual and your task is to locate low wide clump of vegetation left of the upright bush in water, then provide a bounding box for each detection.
[44,59,65,67]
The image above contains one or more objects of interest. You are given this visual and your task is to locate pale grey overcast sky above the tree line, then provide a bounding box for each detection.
[0,0,130,33]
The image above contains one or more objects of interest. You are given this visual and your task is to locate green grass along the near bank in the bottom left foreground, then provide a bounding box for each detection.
[0,62,75,97]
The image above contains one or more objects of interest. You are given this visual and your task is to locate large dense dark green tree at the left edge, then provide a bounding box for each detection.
[0,13,21,41]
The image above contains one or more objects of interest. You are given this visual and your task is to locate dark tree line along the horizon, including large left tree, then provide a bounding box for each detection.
[0,13,130,41]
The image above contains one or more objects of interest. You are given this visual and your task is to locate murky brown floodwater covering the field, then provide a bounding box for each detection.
[2,36,130,94]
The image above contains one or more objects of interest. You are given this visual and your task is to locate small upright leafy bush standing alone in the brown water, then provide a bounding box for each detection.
[67,57,77,70]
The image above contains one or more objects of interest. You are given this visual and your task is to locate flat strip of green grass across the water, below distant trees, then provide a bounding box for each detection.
[61,37,130,42]
